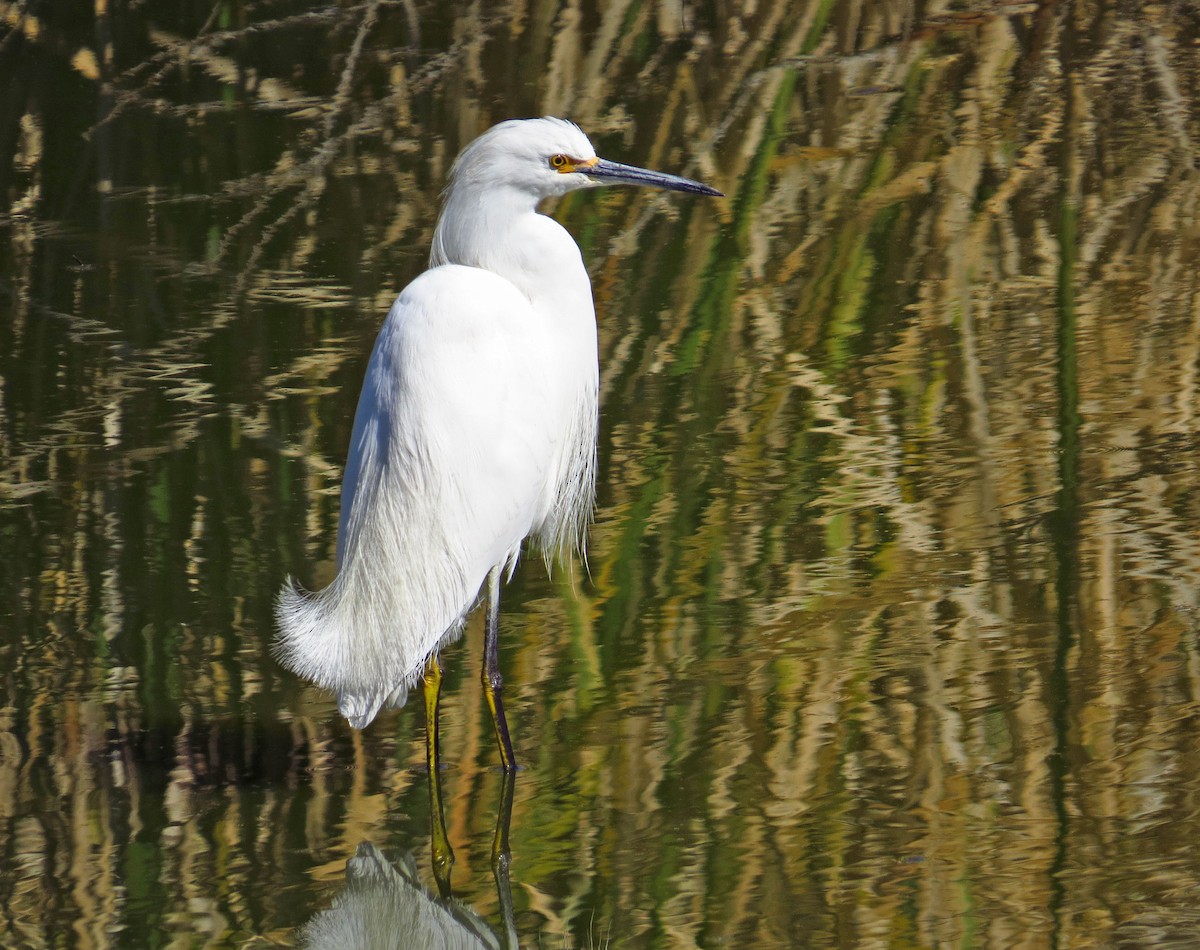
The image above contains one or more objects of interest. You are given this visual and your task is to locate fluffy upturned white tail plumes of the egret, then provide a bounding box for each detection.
[275,573,422,729]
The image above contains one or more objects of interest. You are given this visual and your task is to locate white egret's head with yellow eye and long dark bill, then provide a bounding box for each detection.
[451,118,721,199]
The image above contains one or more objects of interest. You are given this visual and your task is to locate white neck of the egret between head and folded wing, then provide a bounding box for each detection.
[430,187,592,311]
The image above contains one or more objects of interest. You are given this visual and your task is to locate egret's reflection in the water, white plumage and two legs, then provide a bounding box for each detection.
[300,771,517,950]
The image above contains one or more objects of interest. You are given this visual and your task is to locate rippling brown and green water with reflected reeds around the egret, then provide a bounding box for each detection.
[0,0,1200,948]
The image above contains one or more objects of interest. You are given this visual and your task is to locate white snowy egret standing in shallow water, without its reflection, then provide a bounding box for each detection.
[276,119,720,771]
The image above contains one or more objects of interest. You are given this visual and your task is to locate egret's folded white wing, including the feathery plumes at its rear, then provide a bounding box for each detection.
[278,265,562,724]
